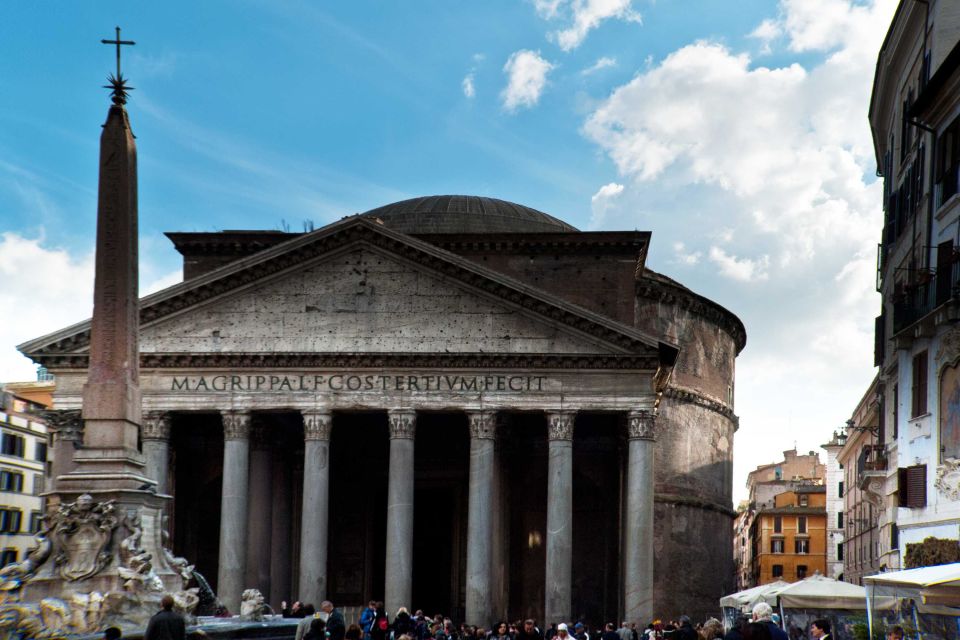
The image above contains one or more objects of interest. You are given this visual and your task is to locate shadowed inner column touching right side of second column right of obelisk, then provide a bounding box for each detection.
[243,418,273,596]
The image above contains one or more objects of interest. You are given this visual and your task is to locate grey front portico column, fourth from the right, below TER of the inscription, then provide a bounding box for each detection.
[384,409,417,612]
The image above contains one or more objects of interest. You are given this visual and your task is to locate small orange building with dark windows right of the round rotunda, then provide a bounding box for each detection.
[750,486,827,585]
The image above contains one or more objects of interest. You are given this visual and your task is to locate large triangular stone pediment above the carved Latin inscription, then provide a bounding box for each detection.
[19,218,673,368]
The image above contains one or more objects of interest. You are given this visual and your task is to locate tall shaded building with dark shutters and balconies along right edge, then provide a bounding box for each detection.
[872,0,960,569]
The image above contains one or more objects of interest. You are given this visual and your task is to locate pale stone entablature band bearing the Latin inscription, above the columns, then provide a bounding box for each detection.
[48,369,655,411]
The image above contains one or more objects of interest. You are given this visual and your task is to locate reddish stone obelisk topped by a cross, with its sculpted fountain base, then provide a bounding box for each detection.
[24,28,187,609]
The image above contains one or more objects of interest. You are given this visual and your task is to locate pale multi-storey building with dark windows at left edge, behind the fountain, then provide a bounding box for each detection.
[0,382,54,566]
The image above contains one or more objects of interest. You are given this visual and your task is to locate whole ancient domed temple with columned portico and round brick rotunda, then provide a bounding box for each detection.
[19,196,746,625]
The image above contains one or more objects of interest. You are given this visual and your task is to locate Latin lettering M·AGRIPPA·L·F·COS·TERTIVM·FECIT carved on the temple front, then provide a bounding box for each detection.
[170,373,547,393]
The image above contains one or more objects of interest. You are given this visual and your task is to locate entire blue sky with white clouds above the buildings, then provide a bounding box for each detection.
[0,0,894,497]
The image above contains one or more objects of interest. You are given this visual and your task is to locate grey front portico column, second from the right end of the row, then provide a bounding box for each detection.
[544,412,576,624]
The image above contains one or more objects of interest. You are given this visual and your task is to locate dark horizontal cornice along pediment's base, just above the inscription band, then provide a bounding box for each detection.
[34,352,659,372]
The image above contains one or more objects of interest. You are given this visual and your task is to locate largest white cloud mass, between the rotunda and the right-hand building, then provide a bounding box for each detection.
[583,0,896,500]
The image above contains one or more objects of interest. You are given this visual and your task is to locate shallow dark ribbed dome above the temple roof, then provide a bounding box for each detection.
[362,196,578,234]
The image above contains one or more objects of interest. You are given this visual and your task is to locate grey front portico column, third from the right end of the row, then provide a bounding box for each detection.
[465,411,497,627]
